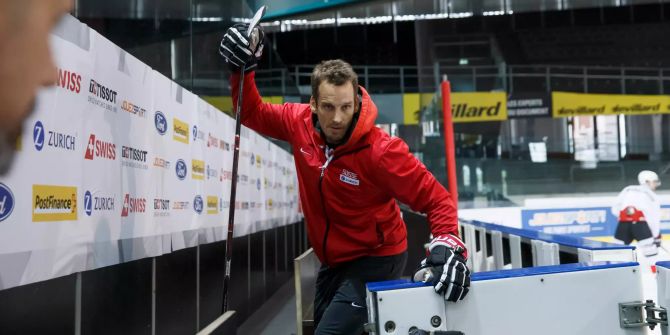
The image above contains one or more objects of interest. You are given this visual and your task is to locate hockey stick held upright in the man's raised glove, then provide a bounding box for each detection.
[222,6,267,314]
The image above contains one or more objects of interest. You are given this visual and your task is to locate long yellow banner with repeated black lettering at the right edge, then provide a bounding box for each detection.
[551,92,670,117]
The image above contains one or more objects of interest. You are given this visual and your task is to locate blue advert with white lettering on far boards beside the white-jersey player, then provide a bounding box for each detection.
[521,205,670,237]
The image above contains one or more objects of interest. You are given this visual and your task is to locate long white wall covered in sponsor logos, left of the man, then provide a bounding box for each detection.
[0,17,301,289]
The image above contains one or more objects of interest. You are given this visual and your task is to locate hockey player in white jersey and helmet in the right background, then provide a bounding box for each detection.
[612,170,661,257]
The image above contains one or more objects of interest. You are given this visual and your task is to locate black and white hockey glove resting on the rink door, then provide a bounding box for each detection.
[414,235,470,302]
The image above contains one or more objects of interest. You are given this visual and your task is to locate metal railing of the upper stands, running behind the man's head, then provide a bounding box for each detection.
[186,63,670,96]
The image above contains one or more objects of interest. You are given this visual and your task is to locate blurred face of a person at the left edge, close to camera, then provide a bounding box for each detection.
[0,0,72,176]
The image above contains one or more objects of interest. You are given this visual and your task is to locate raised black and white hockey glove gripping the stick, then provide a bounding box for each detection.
[219,23,265,73]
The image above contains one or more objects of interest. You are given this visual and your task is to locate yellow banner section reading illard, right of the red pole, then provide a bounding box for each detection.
[451,92,507,123]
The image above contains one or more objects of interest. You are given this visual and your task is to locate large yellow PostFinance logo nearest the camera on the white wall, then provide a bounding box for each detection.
[33,185,77,222]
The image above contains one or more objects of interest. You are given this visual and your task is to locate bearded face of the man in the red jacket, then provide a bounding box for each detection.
[310,81,356,144]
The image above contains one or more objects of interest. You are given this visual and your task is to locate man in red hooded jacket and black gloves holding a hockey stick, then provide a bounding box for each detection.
[219,24,470,334]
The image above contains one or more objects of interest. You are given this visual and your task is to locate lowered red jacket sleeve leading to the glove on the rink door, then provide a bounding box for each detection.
[373,137,458,237]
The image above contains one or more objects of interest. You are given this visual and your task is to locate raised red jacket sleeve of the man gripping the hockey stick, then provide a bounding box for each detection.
[230,71,304,142]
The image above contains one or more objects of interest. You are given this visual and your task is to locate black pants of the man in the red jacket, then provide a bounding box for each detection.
[314,252,407,335]
